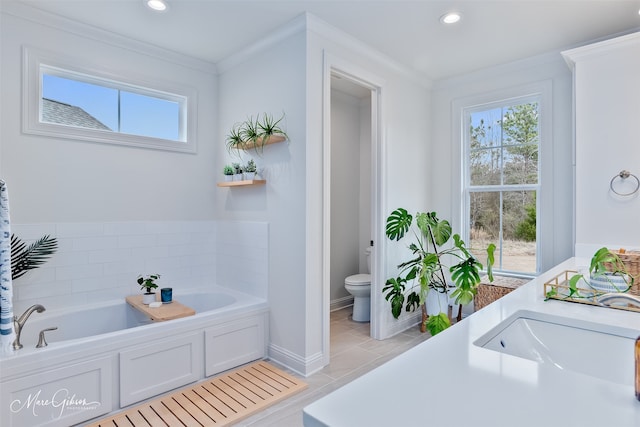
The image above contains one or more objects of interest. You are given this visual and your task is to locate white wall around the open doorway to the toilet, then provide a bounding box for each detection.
[305,17,430,358]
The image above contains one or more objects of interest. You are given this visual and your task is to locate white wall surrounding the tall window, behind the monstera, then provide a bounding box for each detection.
[428,52,573,271]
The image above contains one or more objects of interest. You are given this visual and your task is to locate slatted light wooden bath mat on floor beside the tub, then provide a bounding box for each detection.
[87,361,307,427]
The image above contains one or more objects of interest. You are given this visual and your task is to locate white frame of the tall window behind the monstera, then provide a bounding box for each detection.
[452,80,553,277]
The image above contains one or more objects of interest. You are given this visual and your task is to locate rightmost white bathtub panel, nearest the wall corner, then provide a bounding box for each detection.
[205,316,266,376]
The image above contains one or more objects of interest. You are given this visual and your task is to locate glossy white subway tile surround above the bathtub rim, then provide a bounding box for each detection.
[12,221,268,313]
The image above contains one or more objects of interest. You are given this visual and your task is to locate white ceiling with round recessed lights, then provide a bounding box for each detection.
[13,0,640,80]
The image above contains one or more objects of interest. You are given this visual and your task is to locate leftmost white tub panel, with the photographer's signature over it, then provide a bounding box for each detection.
[0,357,113,426]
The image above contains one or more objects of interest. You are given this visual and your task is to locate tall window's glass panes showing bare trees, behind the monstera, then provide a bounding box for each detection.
[463,96,541,274]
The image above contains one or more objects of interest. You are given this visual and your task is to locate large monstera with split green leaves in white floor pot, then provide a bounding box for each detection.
[382,208,495,335]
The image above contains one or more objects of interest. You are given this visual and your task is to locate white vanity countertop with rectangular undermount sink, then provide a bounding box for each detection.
[303,258,640,427]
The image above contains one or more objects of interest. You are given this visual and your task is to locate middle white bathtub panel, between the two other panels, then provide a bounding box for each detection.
[120,332,203,407]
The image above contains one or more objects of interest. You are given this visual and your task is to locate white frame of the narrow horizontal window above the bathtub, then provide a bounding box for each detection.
[22,46,197,154]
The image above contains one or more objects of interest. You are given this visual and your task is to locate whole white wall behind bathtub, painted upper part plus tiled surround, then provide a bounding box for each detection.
[0,4,268,312]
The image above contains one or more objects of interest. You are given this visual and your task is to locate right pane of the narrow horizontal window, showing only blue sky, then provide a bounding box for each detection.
[120,92,180,141]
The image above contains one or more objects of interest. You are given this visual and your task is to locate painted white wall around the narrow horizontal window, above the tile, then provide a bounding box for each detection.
[0,4,222,224]
